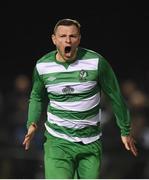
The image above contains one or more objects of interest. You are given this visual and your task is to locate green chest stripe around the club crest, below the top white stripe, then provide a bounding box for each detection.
[42,70,98,85]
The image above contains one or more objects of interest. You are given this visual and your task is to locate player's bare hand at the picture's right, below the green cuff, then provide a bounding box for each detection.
[121,135,138,156]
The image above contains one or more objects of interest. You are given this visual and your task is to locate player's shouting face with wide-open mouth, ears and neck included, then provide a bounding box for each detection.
[52,25,81,61]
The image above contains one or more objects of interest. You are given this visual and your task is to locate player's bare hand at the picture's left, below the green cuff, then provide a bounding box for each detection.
[23,124,37,150]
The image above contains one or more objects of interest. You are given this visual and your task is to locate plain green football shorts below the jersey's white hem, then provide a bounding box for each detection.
[44,135,102,179]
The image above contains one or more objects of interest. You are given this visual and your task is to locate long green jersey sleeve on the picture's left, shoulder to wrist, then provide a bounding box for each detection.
[27,67,47,128]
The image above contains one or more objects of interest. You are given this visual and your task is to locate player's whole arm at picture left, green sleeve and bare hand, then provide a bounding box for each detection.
[23,68,46,150]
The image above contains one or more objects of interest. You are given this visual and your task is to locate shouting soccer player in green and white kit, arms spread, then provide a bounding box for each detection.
[23,19,137,179]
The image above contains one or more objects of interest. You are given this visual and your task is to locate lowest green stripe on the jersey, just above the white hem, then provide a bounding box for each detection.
[46,121,101,138]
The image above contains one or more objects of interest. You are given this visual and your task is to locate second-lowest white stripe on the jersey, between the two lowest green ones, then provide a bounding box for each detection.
[47,112,100,129]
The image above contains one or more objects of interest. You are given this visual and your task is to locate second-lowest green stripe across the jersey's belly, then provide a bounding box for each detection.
[48,105,100,120]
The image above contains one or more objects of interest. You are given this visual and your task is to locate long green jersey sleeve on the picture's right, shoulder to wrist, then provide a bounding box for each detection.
[99,57,131,136]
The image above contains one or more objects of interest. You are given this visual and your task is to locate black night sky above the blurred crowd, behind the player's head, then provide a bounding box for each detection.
[0,0,149,89]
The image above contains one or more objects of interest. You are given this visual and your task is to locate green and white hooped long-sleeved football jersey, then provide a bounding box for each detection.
[27,47,130,144]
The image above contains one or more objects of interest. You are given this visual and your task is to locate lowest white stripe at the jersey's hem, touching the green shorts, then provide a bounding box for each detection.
[45,123,102,144]
